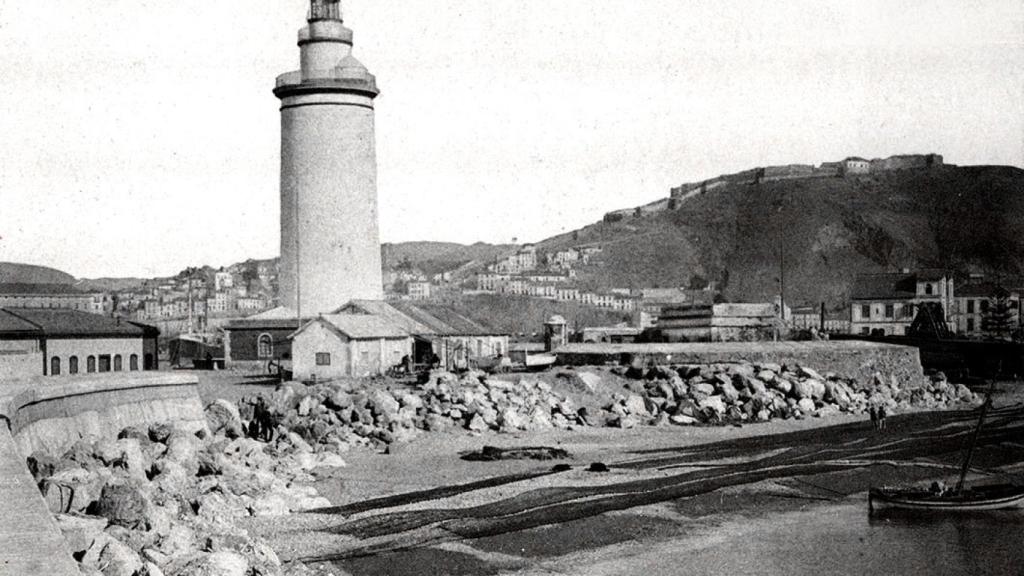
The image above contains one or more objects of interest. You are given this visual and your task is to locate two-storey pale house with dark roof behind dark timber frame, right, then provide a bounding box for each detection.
[850,270,955,335]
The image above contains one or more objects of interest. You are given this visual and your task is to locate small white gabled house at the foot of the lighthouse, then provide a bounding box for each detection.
[291,314,413,381]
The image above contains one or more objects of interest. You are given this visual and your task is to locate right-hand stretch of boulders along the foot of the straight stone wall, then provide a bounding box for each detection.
[602,363,979,427]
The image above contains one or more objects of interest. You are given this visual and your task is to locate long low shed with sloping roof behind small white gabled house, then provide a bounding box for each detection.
[336,300,509,369]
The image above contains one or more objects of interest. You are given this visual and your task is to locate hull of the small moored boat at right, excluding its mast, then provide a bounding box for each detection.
[867,484,1024,512]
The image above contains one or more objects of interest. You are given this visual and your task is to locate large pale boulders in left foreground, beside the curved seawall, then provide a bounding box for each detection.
[29,412,345,576]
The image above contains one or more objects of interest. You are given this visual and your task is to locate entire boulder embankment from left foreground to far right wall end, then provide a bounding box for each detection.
[29,364,978,576]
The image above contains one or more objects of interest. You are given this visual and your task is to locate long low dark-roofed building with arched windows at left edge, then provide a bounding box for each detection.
[0,308,160,378]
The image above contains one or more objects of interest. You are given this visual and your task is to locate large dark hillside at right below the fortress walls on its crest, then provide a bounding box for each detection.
[539,165,1024,304]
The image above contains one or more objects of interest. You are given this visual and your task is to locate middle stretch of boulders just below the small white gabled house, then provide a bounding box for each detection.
[234,372,584,451]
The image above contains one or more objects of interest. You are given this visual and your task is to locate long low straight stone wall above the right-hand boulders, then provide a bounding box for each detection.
[555,341,924,381]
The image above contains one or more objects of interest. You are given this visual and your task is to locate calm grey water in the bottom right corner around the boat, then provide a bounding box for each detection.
[684,502,1024,576]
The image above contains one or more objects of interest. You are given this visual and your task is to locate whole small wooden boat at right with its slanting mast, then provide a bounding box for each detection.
[867,380,1024,512]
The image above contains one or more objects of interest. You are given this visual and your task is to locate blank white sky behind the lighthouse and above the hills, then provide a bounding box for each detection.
[0,0,1024,277]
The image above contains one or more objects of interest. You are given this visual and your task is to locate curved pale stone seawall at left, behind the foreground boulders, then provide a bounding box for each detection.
[0,372,206,456]
